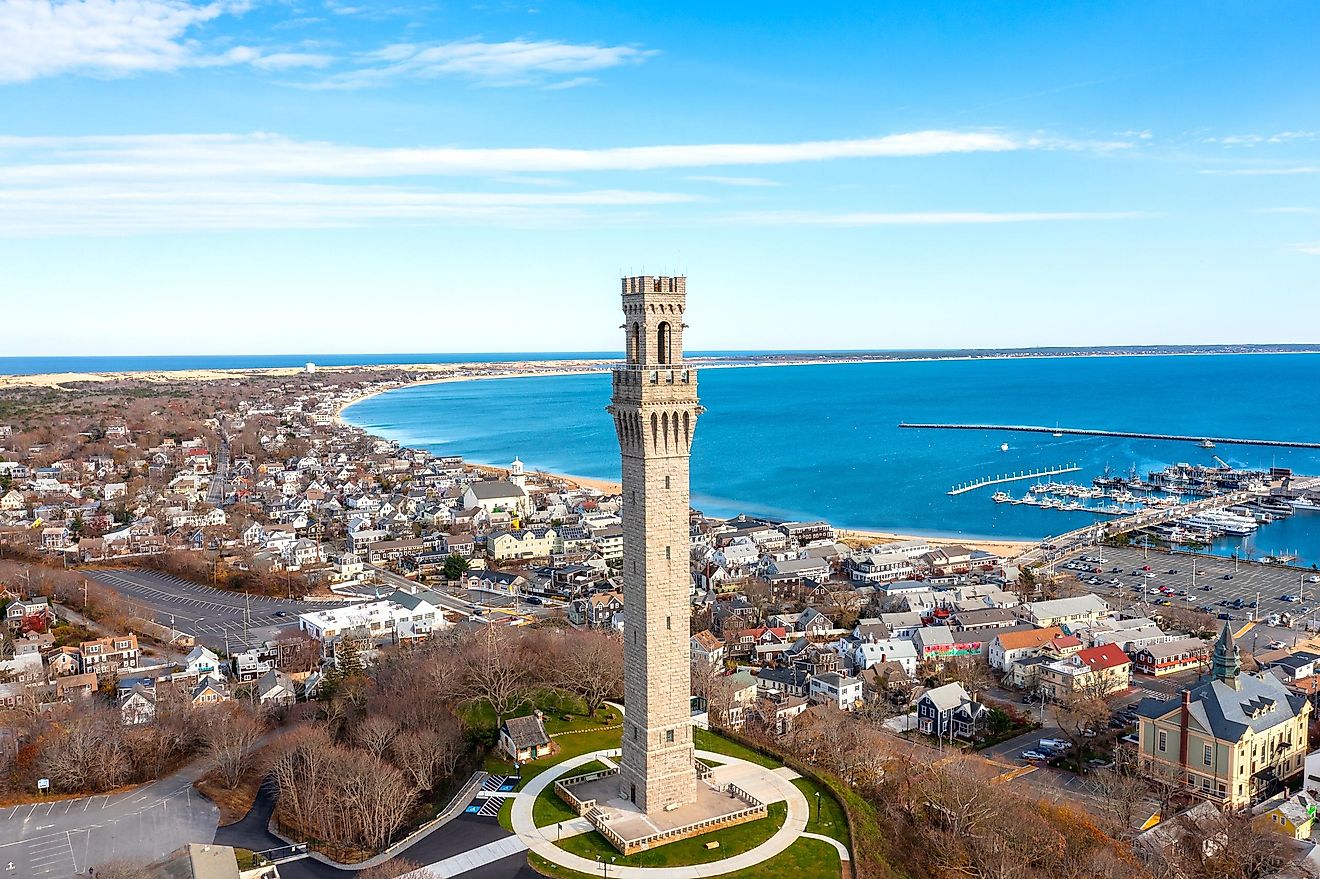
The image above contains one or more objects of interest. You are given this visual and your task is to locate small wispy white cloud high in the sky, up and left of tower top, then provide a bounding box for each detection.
[317,40,655,88]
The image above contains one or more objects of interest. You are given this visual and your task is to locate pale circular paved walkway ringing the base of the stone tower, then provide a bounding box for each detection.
[511,748,810,879]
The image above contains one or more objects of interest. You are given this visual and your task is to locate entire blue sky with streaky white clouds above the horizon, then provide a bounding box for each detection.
[0,0,1320,355]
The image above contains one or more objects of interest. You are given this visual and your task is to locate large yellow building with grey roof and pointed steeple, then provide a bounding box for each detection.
[1138,624,1311,809]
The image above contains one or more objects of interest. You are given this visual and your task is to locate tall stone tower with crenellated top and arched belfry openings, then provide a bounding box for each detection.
[609,276,702,814]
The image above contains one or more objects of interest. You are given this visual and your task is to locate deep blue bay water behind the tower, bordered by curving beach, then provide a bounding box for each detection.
[345,354,1320,564]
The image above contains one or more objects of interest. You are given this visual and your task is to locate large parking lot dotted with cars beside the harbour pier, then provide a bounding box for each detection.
[1059,546,1320,630]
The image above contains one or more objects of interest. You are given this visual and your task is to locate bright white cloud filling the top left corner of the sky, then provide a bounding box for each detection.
[0,0,331,83]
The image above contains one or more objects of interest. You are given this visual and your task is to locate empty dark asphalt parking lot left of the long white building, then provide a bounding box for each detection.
[88,570,337,649]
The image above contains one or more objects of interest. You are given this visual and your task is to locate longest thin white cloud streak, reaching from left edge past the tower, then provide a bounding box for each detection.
[0,131,1024,185]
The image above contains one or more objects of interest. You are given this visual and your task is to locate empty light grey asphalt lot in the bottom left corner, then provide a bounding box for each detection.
[0,771,218,879]
